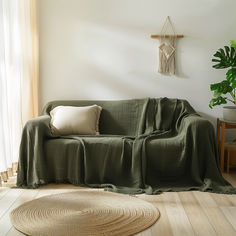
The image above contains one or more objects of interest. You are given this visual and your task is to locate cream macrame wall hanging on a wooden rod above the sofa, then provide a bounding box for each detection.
[151,16,184,75]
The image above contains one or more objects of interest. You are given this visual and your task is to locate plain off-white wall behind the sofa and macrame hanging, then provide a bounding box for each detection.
[38,0,236,127]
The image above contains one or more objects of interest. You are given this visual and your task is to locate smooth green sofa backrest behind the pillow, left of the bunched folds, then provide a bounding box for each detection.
[43,99,148,136]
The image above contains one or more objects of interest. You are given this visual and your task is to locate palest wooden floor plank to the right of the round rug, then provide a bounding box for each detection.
[162,192,194,236]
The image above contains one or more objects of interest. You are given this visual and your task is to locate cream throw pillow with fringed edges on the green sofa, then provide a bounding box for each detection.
[50,105,102,135]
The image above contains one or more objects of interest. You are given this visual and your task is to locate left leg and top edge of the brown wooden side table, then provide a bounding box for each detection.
[216,118,236,172]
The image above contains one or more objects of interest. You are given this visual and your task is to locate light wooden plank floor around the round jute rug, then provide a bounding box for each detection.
[0,172,236,236]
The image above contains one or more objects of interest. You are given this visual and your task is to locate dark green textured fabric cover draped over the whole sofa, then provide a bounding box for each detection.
[17,98,236,194]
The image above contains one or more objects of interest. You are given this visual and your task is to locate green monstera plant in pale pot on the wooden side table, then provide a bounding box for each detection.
[209,40,236,122]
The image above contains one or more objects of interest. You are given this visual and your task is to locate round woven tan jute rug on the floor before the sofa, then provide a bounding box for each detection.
[10,190,160,236]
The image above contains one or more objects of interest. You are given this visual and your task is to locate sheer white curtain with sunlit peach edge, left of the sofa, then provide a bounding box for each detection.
[0,0,38,183]
